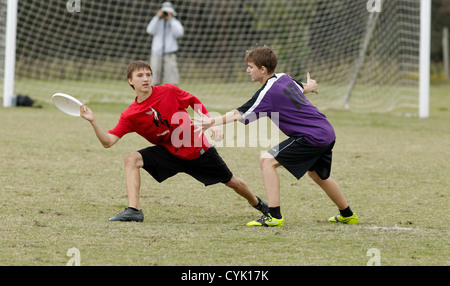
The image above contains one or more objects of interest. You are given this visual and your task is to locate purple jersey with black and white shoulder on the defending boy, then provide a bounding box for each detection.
[237,73,336,146]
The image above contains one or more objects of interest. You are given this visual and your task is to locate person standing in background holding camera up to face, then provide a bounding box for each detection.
[147,2,184,85]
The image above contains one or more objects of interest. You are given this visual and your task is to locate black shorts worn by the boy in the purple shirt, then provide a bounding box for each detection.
[268,137,335,180]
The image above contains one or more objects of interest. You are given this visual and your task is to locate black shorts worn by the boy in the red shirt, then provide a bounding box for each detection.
[138,146,233,186]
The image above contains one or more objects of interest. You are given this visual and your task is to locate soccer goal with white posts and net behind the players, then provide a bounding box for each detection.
[0,0,431,117]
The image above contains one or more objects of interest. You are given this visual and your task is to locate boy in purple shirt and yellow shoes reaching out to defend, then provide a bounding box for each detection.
[197,47,359,227]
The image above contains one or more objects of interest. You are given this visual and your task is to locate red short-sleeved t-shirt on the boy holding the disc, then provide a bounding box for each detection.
[109,84,210,160]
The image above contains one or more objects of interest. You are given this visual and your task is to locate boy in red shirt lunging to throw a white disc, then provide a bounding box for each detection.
[80,61,268,222]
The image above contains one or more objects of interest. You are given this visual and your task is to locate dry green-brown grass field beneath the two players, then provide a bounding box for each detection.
[0,82,450,266]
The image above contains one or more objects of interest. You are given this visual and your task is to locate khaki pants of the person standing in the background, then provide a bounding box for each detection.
[150,53,180,85]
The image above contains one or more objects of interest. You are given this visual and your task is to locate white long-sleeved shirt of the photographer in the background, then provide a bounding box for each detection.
[147,16,184,55]
